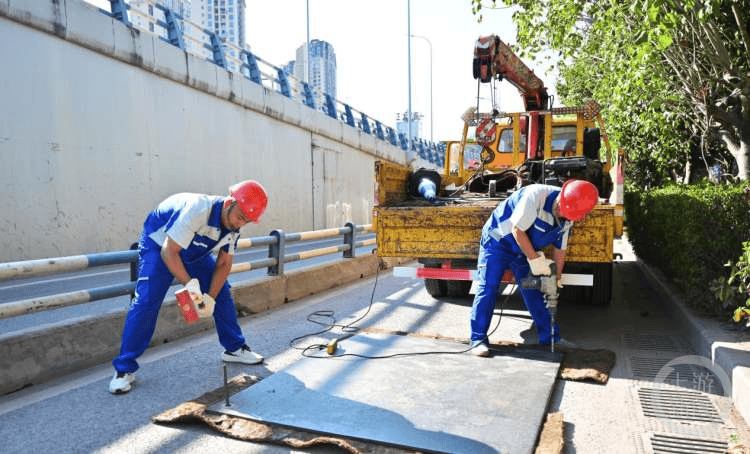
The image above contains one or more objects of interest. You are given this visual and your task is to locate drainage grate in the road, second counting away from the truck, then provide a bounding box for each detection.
[630,356,724,394]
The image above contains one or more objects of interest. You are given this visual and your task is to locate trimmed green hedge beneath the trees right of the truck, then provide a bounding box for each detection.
[625,183,750,315]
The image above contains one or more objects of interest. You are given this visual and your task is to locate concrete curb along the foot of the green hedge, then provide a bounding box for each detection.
[637,259,750,421]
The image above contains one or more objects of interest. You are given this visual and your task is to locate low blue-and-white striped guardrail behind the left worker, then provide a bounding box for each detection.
[0,222,375,319]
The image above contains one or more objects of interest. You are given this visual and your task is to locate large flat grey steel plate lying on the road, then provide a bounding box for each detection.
[210,333,561,454]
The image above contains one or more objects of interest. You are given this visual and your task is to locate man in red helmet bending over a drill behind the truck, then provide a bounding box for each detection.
[471,180,599,356]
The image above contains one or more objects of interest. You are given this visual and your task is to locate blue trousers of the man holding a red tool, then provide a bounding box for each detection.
[112,244,245,372]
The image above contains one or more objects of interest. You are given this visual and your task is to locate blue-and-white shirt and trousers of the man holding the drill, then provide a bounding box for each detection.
[471,184,572,345]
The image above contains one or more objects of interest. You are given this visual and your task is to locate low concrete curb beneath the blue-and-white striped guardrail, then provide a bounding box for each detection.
[0,255,411,395]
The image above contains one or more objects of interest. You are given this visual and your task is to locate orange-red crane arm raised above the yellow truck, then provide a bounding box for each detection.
[473,35,549,111]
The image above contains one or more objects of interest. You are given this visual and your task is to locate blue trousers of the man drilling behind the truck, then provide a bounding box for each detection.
[471,232,560,345]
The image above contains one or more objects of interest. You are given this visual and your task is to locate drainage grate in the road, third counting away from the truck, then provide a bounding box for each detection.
[638,388,724,423]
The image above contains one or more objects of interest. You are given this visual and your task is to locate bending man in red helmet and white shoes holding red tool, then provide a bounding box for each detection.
[109,180,268,394]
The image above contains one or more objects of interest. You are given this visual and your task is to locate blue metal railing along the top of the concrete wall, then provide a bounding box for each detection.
[100,0,445,168]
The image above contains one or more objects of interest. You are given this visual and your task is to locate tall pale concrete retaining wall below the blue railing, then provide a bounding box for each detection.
[0,0,418,262]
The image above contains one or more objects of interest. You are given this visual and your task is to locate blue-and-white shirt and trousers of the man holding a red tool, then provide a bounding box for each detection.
[112,193,245,372]
